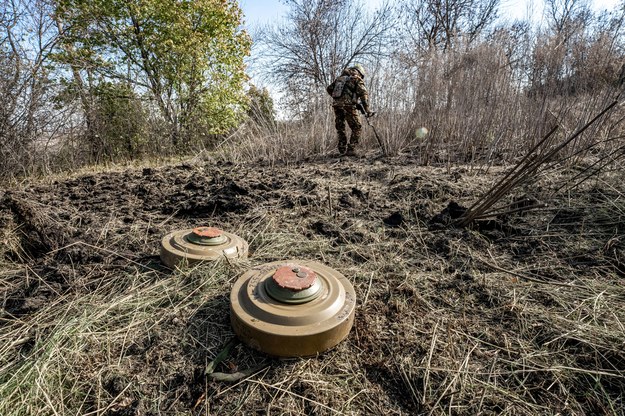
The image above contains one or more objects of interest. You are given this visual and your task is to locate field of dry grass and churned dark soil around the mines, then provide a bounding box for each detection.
[0,155,625,416]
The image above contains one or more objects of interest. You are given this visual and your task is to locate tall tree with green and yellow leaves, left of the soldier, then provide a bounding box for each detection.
[55,0,250,146]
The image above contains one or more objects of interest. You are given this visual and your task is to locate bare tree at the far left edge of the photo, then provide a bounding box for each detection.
[0,0,56,176]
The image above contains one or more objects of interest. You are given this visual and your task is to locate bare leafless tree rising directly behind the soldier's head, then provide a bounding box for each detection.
[257,0,395,115]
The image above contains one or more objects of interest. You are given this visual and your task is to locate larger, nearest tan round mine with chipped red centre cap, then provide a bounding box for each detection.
[230,260,356,357]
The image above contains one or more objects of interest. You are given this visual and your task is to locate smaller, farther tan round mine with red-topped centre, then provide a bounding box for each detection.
[161,227,249,268]
